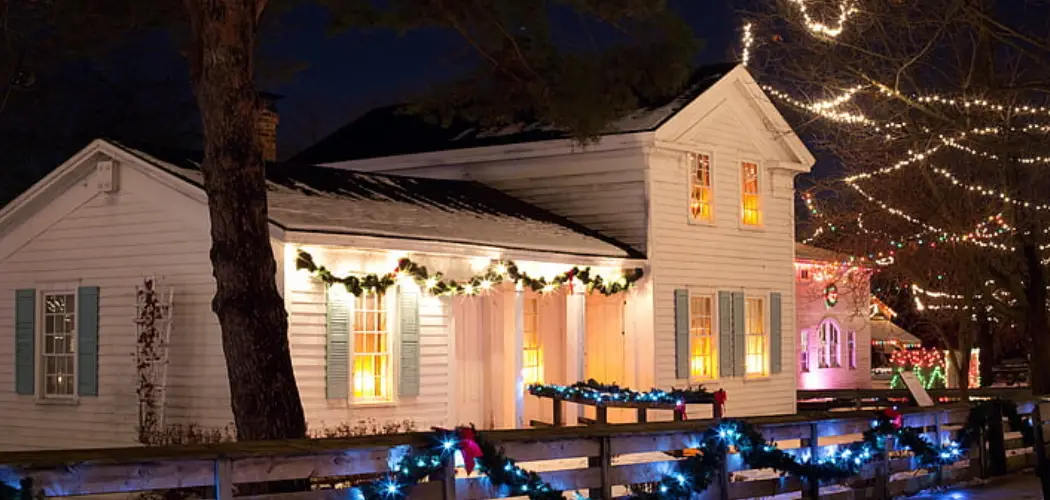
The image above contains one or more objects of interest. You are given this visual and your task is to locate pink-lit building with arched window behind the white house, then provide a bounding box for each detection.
[795,244,872,389]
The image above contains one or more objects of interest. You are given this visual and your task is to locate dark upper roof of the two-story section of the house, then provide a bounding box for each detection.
[293,63,737,164]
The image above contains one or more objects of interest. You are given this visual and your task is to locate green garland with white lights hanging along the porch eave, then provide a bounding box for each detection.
[295,250,644,296]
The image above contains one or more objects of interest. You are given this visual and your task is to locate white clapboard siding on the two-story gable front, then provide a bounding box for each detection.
[649,97,796,416]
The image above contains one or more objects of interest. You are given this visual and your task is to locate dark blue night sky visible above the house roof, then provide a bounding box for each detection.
[260,0,738,157]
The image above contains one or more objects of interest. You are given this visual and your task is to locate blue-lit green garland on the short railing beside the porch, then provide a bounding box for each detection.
[528,378,714,404]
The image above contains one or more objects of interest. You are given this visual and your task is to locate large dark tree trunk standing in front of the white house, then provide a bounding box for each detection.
[185,0,307,440]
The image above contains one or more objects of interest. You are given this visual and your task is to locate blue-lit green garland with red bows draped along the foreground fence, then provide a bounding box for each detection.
[348,407,981,500]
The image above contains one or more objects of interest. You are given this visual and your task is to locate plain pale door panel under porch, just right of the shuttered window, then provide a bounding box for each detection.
[453,297,494,429]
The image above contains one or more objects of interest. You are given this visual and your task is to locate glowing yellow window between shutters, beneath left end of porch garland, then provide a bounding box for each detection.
[351,293,394,401]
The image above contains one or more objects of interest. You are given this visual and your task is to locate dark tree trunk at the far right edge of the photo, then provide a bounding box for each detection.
[1022,242,1050,395]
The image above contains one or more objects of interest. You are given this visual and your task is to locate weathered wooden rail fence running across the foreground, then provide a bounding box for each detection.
[0,401,1050,500]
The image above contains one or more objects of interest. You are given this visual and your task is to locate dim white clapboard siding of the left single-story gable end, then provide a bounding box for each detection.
[0,167,231,451]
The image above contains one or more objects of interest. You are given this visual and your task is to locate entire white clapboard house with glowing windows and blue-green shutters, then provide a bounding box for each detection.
[0,61,814,450]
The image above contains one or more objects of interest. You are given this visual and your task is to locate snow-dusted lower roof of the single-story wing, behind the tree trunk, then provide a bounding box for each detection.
[112,139,644,258]
